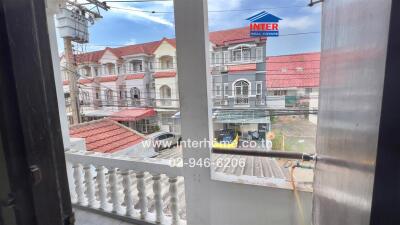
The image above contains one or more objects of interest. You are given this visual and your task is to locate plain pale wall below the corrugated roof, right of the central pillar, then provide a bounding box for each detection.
[210,181,312,225]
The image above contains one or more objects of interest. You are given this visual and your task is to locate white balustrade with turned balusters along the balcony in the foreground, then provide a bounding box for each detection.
[65,151,186,225]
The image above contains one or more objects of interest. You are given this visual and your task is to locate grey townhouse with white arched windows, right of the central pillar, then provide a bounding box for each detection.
[210,28,270,140]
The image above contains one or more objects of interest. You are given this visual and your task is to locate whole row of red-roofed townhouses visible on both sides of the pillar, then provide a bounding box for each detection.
[61,27,269,135]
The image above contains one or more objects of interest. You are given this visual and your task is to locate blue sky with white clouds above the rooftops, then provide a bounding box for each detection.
[58,0,321,56]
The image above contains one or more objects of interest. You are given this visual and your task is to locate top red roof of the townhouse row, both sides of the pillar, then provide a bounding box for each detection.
[76,27,266,63]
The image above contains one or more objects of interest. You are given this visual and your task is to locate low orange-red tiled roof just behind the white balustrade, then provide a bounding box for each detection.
[70,119,144,153]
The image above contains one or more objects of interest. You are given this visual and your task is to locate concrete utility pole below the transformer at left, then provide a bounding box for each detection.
[64,37,81,124]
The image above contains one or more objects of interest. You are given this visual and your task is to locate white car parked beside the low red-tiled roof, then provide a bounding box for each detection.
[147,131,181,152]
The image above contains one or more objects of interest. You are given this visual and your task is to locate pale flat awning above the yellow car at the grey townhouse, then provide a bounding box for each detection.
[213,110,270,124]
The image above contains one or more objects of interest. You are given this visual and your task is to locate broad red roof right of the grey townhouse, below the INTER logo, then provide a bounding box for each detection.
[266,52,321,88]
